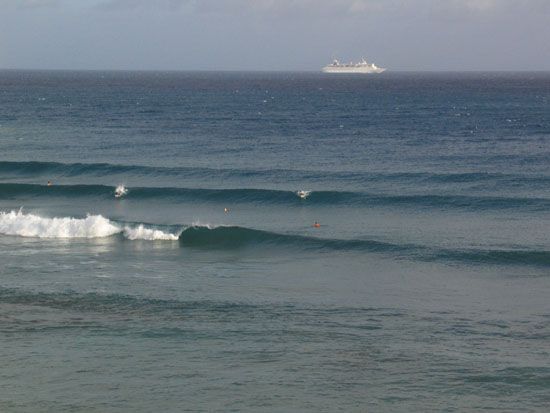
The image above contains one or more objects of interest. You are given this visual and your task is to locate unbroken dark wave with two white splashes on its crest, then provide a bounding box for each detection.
[0,183,550,210]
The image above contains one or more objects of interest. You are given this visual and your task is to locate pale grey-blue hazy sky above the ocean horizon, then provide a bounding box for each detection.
[0,0,550,71]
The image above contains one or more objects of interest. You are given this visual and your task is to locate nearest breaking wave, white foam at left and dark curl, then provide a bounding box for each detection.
[0,210,550,267]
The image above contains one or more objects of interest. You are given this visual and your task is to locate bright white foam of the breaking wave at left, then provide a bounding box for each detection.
[0,210,179,241]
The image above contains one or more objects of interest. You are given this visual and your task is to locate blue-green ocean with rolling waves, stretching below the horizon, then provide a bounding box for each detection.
[0,70,550,413]
